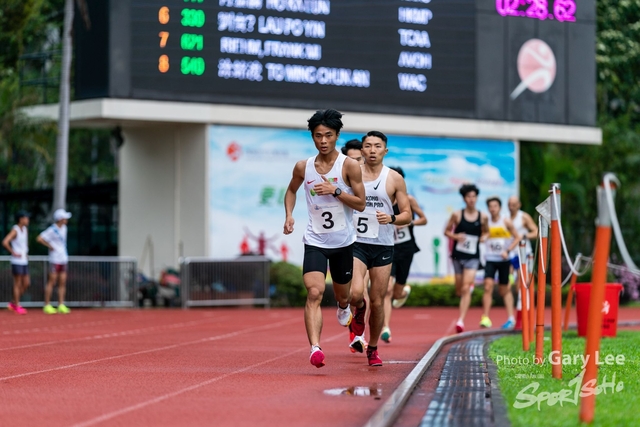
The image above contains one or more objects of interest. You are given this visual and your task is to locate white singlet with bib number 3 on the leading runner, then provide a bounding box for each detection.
[302,153,356,249]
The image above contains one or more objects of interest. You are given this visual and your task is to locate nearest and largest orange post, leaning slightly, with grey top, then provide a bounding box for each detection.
[580,178,611,423]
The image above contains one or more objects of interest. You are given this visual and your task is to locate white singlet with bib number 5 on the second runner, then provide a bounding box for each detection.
[353,166,395,246]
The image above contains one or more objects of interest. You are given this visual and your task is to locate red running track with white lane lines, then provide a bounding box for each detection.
[0,308,640,427]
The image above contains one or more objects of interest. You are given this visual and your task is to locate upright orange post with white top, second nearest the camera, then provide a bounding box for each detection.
[549,184,562,379]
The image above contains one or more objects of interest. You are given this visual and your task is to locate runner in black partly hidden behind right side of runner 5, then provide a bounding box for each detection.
[380,167,427,343]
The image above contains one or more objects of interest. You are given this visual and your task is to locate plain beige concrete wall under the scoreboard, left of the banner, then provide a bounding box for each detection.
[119,124,208,278]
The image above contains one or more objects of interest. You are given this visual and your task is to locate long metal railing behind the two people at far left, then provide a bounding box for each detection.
[0,256,138,307]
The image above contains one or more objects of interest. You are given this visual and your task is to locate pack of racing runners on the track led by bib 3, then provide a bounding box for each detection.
[284,109,537,368]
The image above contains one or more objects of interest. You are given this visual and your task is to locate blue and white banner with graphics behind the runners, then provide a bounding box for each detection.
[208,126,518,282]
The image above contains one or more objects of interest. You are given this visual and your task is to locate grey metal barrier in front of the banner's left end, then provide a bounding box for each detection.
[180,256,271,308]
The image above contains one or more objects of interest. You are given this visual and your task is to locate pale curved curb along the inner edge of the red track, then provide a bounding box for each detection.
[363,320,640,427]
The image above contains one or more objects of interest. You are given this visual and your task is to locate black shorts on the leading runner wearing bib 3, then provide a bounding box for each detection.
[302,245,353,285]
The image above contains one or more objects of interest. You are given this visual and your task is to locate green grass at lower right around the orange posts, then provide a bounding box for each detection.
[489,331,640,427]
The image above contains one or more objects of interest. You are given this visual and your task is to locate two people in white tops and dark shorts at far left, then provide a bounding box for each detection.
[2,209,71,314]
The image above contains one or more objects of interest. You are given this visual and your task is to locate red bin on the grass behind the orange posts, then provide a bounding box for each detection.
[574,283,622,337]
